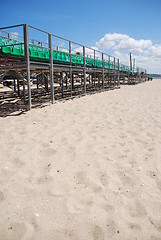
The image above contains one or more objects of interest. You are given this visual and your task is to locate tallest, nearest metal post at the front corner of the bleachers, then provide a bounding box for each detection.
[23,24,31,110]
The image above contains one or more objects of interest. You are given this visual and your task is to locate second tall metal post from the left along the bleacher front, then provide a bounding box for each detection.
[48,33,54,103]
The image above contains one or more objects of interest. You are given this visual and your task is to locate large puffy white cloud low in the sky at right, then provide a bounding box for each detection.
[96,33,161,73]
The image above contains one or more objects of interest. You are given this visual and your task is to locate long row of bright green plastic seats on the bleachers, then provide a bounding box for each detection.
[0,37,132,72]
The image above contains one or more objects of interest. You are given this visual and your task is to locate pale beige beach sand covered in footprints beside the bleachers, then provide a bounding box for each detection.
[0,80,161,240]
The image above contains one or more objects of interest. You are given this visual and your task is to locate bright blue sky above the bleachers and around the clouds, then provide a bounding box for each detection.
[0,0,161,73]
